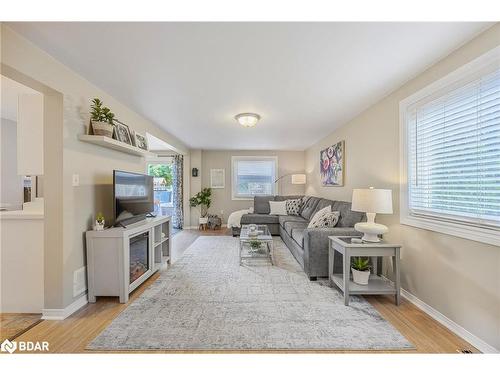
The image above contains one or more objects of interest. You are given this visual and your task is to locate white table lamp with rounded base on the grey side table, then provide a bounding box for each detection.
[351,187,392,242]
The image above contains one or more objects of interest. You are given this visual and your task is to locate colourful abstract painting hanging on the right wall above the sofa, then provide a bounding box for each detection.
[319,141,344,186]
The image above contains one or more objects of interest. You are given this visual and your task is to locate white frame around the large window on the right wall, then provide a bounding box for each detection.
[399,47,500,246]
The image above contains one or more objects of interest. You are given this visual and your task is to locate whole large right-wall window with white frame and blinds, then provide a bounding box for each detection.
[401,47,500,244]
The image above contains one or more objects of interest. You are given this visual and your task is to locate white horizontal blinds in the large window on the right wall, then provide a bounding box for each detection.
[406,68,500,228]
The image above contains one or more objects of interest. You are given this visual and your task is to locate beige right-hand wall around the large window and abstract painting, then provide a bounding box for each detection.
[306,24,500,350]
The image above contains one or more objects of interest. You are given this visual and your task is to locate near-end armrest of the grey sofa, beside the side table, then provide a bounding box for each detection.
[304,227,362,277]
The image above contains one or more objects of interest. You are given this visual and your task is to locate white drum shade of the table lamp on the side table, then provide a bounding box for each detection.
[351,188,392,214]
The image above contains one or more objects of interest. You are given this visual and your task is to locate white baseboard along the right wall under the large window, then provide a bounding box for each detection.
[384,277,500,353]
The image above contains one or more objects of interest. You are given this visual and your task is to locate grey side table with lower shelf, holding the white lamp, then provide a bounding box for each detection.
[328,236,401,306]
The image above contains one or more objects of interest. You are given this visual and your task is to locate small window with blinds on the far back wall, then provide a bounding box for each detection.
[232,156,278,199]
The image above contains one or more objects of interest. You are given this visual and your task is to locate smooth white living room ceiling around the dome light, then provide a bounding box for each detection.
[9,22,490,150]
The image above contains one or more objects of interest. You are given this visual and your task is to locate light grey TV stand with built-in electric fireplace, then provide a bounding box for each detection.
[86,216,172,303]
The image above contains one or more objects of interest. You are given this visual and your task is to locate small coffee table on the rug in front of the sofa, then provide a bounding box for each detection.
[240,225,274,265]
